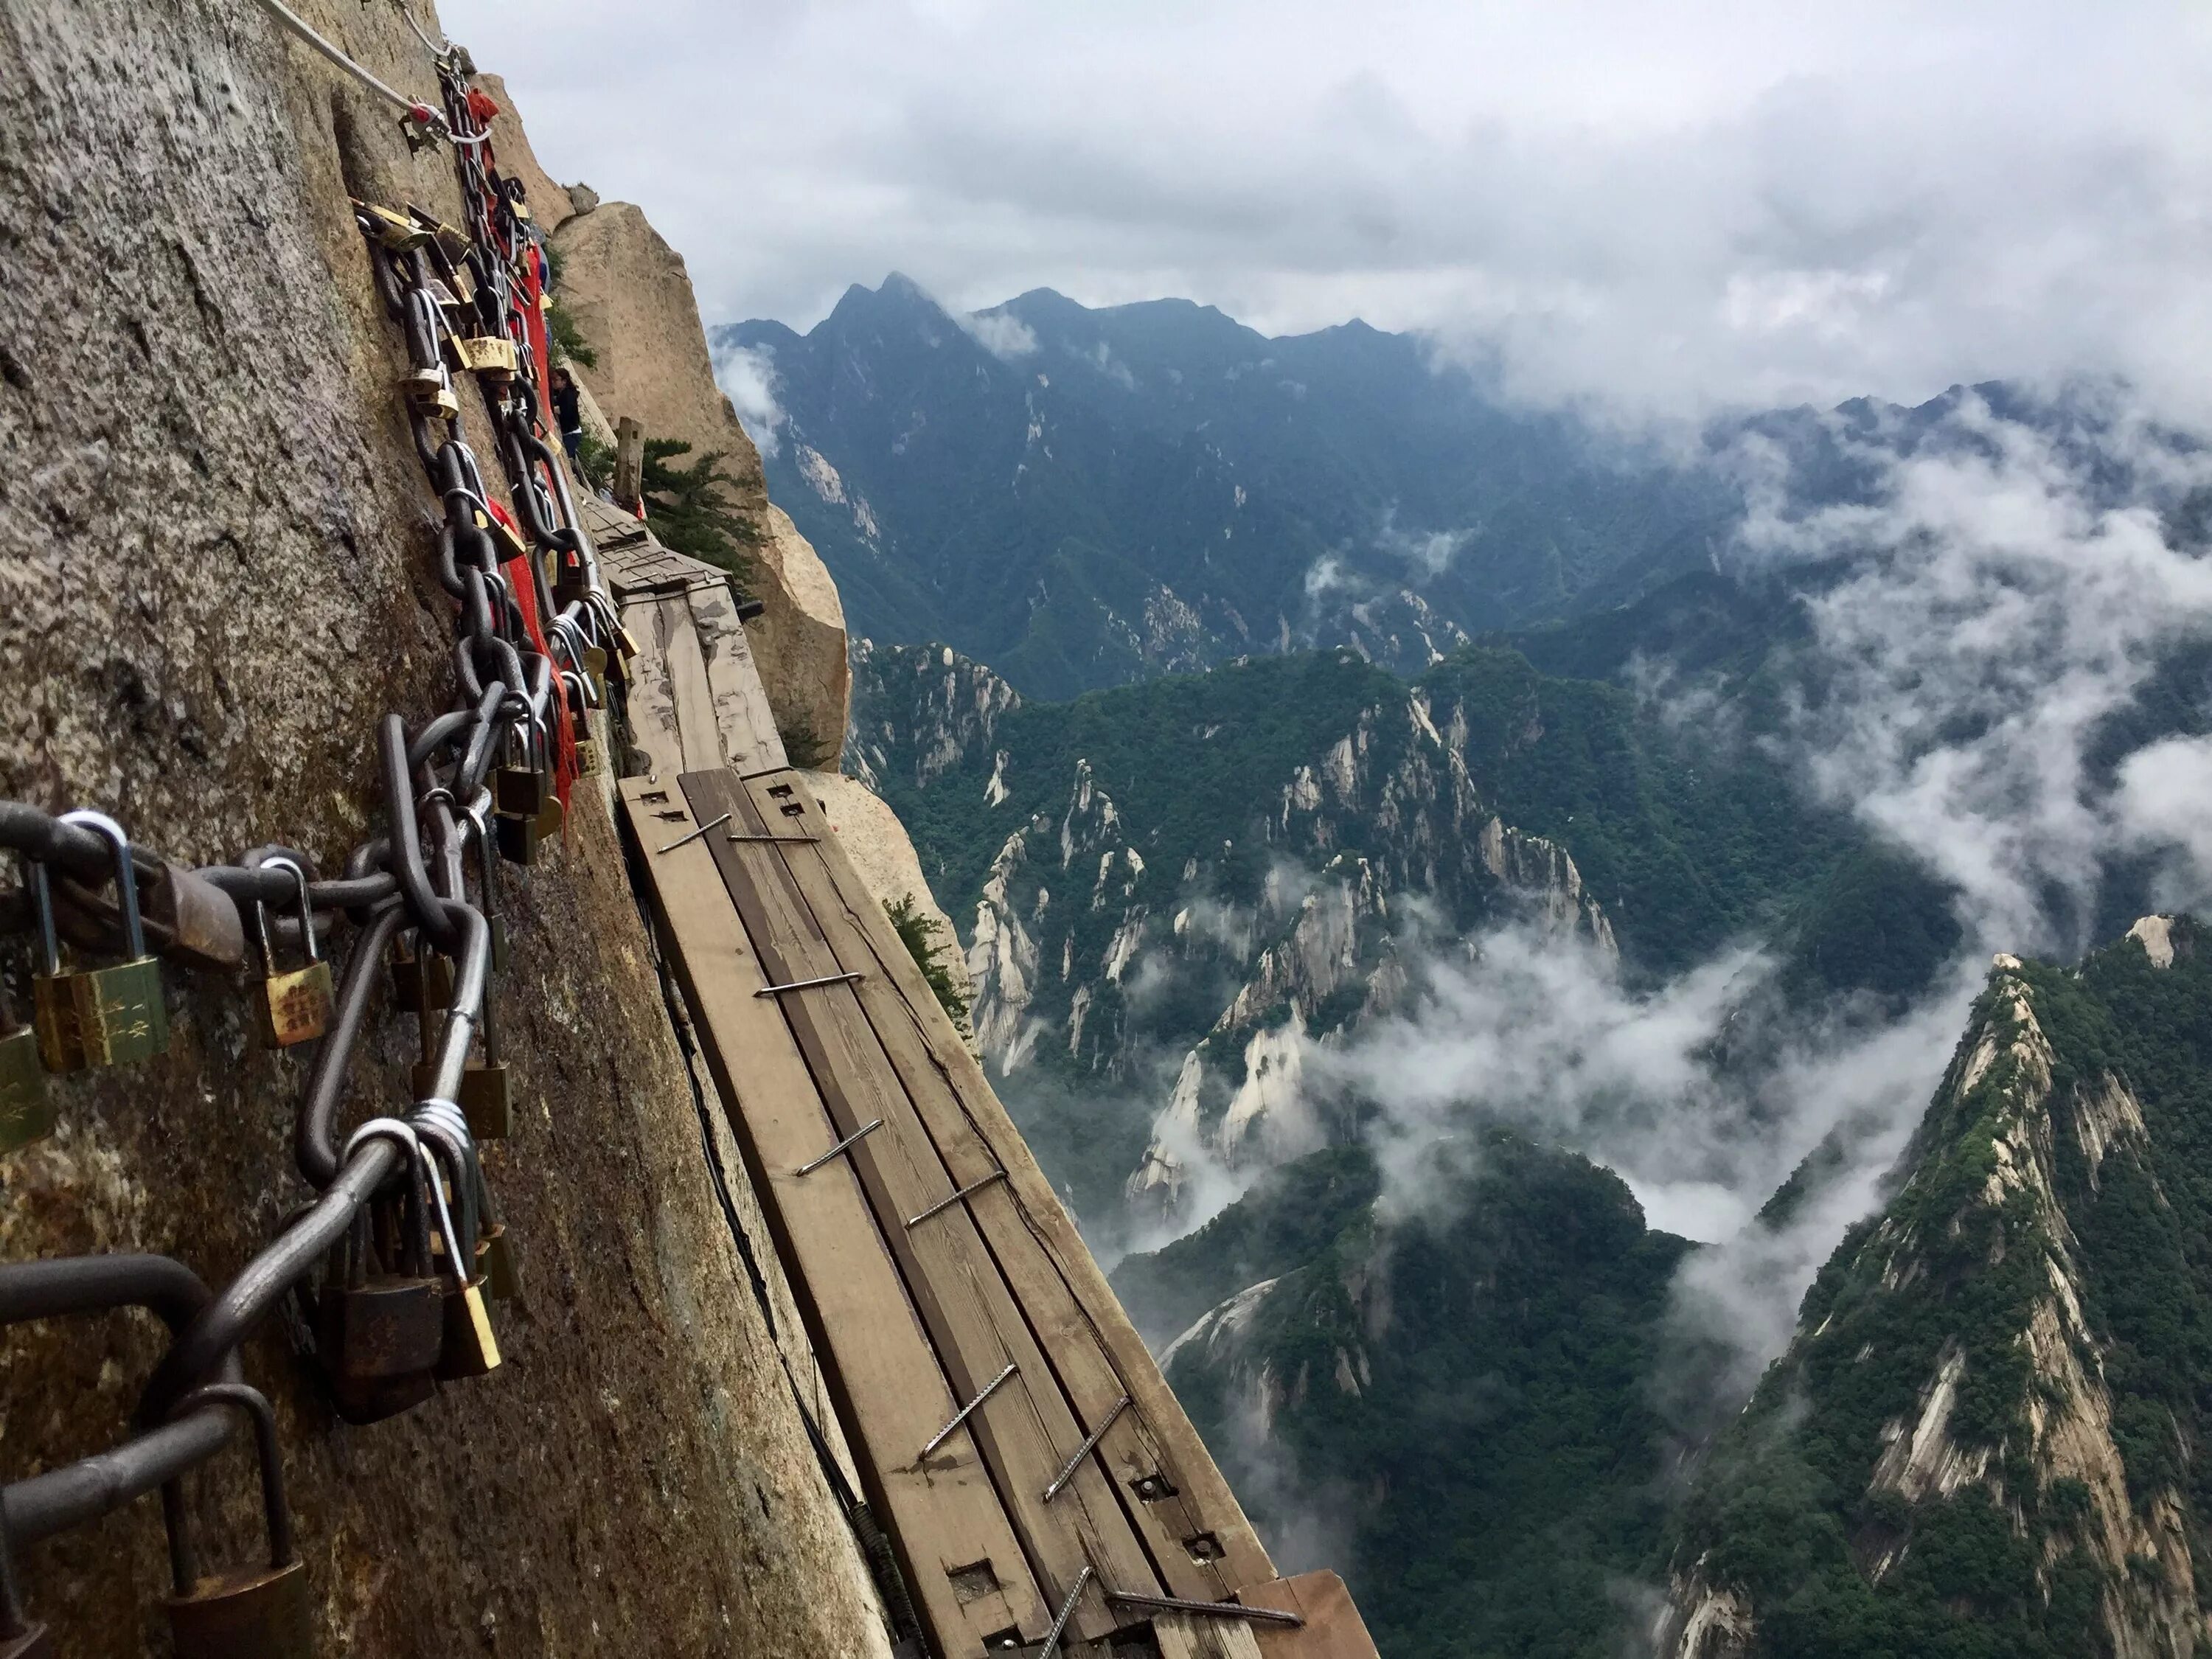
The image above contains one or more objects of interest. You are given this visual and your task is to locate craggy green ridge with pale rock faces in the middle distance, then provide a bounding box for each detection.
[847,646,1615,1221]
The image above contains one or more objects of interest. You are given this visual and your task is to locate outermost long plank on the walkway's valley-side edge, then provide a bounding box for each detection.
[748,779,1274,1601]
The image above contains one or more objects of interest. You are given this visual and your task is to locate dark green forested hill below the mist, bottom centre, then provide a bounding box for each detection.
[1115,1130,1692,1659]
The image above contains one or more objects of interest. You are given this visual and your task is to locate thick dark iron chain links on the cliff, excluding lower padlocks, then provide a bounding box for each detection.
[0,32,626,1575]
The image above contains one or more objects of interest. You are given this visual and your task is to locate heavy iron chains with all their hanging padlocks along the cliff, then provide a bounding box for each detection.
[0,22,630,1652]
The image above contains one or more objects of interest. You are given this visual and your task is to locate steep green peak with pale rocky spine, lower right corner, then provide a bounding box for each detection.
[1657,918,2212,1659]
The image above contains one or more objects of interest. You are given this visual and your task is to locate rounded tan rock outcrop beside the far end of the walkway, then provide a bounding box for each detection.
[553,201,852,765]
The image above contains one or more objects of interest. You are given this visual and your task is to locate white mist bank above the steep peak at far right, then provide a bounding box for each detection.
[1734,398,2212,956]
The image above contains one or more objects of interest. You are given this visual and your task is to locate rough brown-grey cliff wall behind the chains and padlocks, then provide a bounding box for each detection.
[0,0,885,1659]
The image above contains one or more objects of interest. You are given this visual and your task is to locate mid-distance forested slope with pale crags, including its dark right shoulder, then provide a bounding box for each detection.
[847,606,1955,1225]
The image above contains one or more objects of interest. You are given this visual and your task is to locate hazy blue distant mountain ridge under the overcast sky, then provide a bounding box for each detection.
[714,274,1736,697]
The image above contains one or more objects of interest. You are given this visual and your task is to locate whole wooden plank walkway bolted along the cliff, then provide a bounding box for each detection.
[593,509,1374,1659]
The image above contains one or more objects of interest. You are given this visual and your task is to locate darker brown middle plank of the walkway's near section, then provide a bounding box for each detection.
[681,772,1157,1639]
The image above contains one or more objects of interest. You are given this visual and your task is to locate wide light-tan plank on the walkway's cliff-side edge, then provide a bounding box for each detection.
[622,779,1051,1652]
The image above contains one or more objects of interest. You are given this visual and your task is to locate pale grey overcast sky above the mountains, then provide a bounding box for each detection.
[445,0,2212,409]
